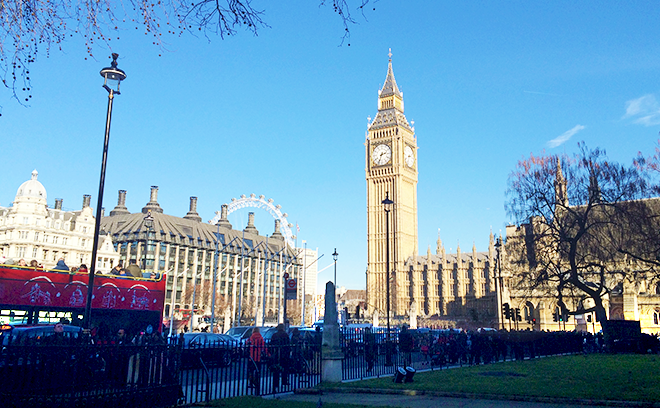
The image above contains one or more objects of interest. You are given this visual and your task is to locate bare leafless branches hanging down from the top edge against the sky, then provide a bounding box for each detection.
[0,0,374,109]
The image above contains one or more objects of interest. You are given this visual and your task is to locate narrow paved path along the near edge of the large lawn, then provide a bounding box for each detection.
[271,389,660,408]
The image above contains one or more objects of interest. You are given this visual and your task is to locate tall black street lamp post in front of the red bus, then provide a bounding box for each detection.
[83,53,126,329]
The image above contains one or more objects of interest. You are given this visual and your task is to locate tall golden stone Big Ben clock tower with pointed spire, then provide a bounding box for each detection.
[365,52,417,316]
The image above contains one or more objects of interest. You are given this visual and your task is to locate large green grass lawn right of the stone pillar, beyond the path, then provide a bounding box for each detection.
[332,354,660,401]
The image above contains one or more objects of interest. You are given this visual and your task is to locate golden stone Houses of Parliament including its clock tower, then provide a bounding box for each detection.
[365,54,660,333]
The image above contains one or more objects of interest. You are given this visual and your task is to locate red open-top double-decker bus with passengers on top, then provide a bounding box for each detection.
[0,265,166,335]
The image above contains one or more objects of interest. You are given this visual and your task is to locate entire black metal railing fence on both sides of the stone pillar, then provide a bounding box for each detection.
[0,328,582,408]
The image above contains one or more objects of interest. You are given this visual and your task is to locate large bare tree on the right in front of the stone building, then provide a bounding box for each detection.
[506,144,657,321]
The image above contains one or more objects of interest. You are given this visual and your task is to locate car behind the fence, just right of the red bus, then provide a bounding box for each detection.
[181,333,237,368]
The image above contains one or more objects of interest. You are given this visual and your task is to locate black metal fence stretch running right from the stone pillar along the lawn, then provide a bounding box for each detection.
[340,328,583,380]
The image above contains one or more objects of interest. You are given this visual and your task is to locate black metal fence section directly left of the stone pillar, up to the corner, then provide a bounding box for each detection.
[179,343,321,404]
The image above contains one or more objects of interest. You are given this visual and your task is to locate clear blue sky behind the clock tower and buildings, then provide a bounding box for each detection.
[0,0,660,294]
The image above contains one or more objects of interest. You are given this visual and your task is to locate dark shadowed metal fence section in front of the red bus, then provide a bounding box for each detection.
[0,343,183,407]
